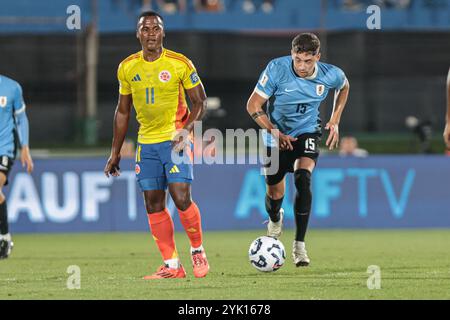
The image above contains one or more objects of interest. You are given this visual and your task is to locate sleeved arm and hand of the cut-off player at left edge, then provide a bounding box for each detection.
[14,85,34,173]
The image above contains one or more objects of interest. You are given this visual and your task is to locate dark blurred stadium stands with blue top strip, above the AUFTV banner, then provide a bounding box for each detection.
[0,0,450,153]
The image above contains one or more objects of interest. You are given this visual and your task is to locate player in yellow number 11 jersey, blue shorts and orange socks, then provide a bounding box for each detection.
[105,11,209,279]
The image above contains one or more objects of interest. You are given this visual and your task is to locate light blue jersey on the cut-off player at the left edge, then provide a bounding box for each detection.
[0,75,28,158]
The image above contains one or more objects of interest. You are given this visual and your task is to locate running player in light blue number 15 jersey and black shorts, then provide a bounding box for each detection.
[247,33,350,267]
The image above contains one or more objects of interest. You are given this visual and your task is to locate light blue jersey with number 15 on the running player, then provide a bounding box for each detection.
[255,56,346,146]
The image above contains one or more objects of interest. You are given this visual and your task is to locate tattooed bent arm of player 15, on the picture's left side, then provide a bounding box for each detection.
[247,63,297,150]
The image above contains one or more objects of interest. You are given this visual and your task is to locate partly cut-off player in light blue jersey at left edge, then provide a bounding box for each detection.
[0,75,33,259]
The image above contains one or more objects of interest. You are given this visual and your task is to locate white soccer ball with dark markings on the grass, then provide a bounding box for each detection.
[248,236,286,272]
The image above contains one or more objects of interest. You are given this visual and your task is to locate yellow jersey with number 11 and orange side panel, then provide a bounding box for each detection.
[117,49,201,144]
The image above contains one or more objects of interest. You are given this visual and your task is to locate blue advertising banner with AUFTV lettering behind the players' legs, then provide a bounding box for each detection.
[5,156,450,232]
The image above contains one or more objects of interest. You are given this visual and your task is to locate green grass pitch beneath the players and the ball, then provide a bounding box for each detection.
[0,230,450,300]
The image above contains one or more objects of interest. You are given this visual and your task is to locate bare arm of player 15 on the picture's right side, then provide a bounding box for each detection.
[325,79,350,150]
